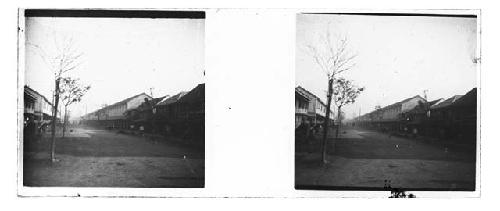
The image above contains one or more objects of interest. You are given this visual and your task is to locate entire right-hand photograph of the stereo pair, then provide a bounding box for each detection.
[294,10,481,193]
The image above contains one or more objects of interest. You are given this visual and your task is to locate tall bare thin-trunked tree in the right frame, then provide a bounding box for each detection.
[307,30,356,163]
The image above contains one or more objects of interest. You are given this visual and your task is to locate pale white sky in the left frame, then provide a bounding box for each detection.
[25,17,205,117]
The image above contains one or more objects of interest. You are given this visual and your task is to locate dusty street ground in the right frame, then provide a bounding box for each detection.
[295,129,475,190]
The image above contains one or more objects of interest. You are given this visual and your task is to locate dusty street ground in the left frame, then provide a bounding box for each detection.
[23,129,204,188]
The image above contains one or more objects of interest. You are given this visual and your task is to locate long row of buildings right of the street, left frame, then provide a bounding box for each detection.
[80,84,205,141]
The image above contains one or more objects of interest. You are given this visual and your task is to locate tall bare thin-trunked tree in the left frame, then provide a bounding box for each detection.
[26,32,83,162]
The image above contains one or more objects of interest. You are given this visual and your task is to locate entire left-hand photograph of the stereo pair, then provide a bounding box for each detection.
[18,9,205,191]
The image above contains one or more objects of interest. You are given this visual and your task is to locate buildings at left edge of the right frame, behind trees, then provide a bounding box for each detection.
[295,86,335,128]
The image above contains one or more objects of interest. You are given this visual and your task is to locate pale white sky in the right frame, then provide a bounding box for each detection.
[296,14,477,118]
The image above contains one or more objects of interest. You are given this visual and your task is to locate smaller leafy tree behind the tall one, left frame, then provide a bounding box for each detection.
[60,77,90,138]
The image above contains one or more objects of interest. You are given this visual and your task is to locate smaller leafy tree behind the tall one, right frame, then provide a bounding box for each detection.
[333,78,364,138]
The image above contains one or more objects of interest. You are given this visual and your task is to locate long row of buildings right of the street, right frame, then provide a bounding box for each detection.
[352,88,477,143]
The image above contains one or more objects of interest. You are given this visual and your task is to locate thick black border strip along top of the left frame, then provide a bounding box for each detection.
[24,9,205,19]
